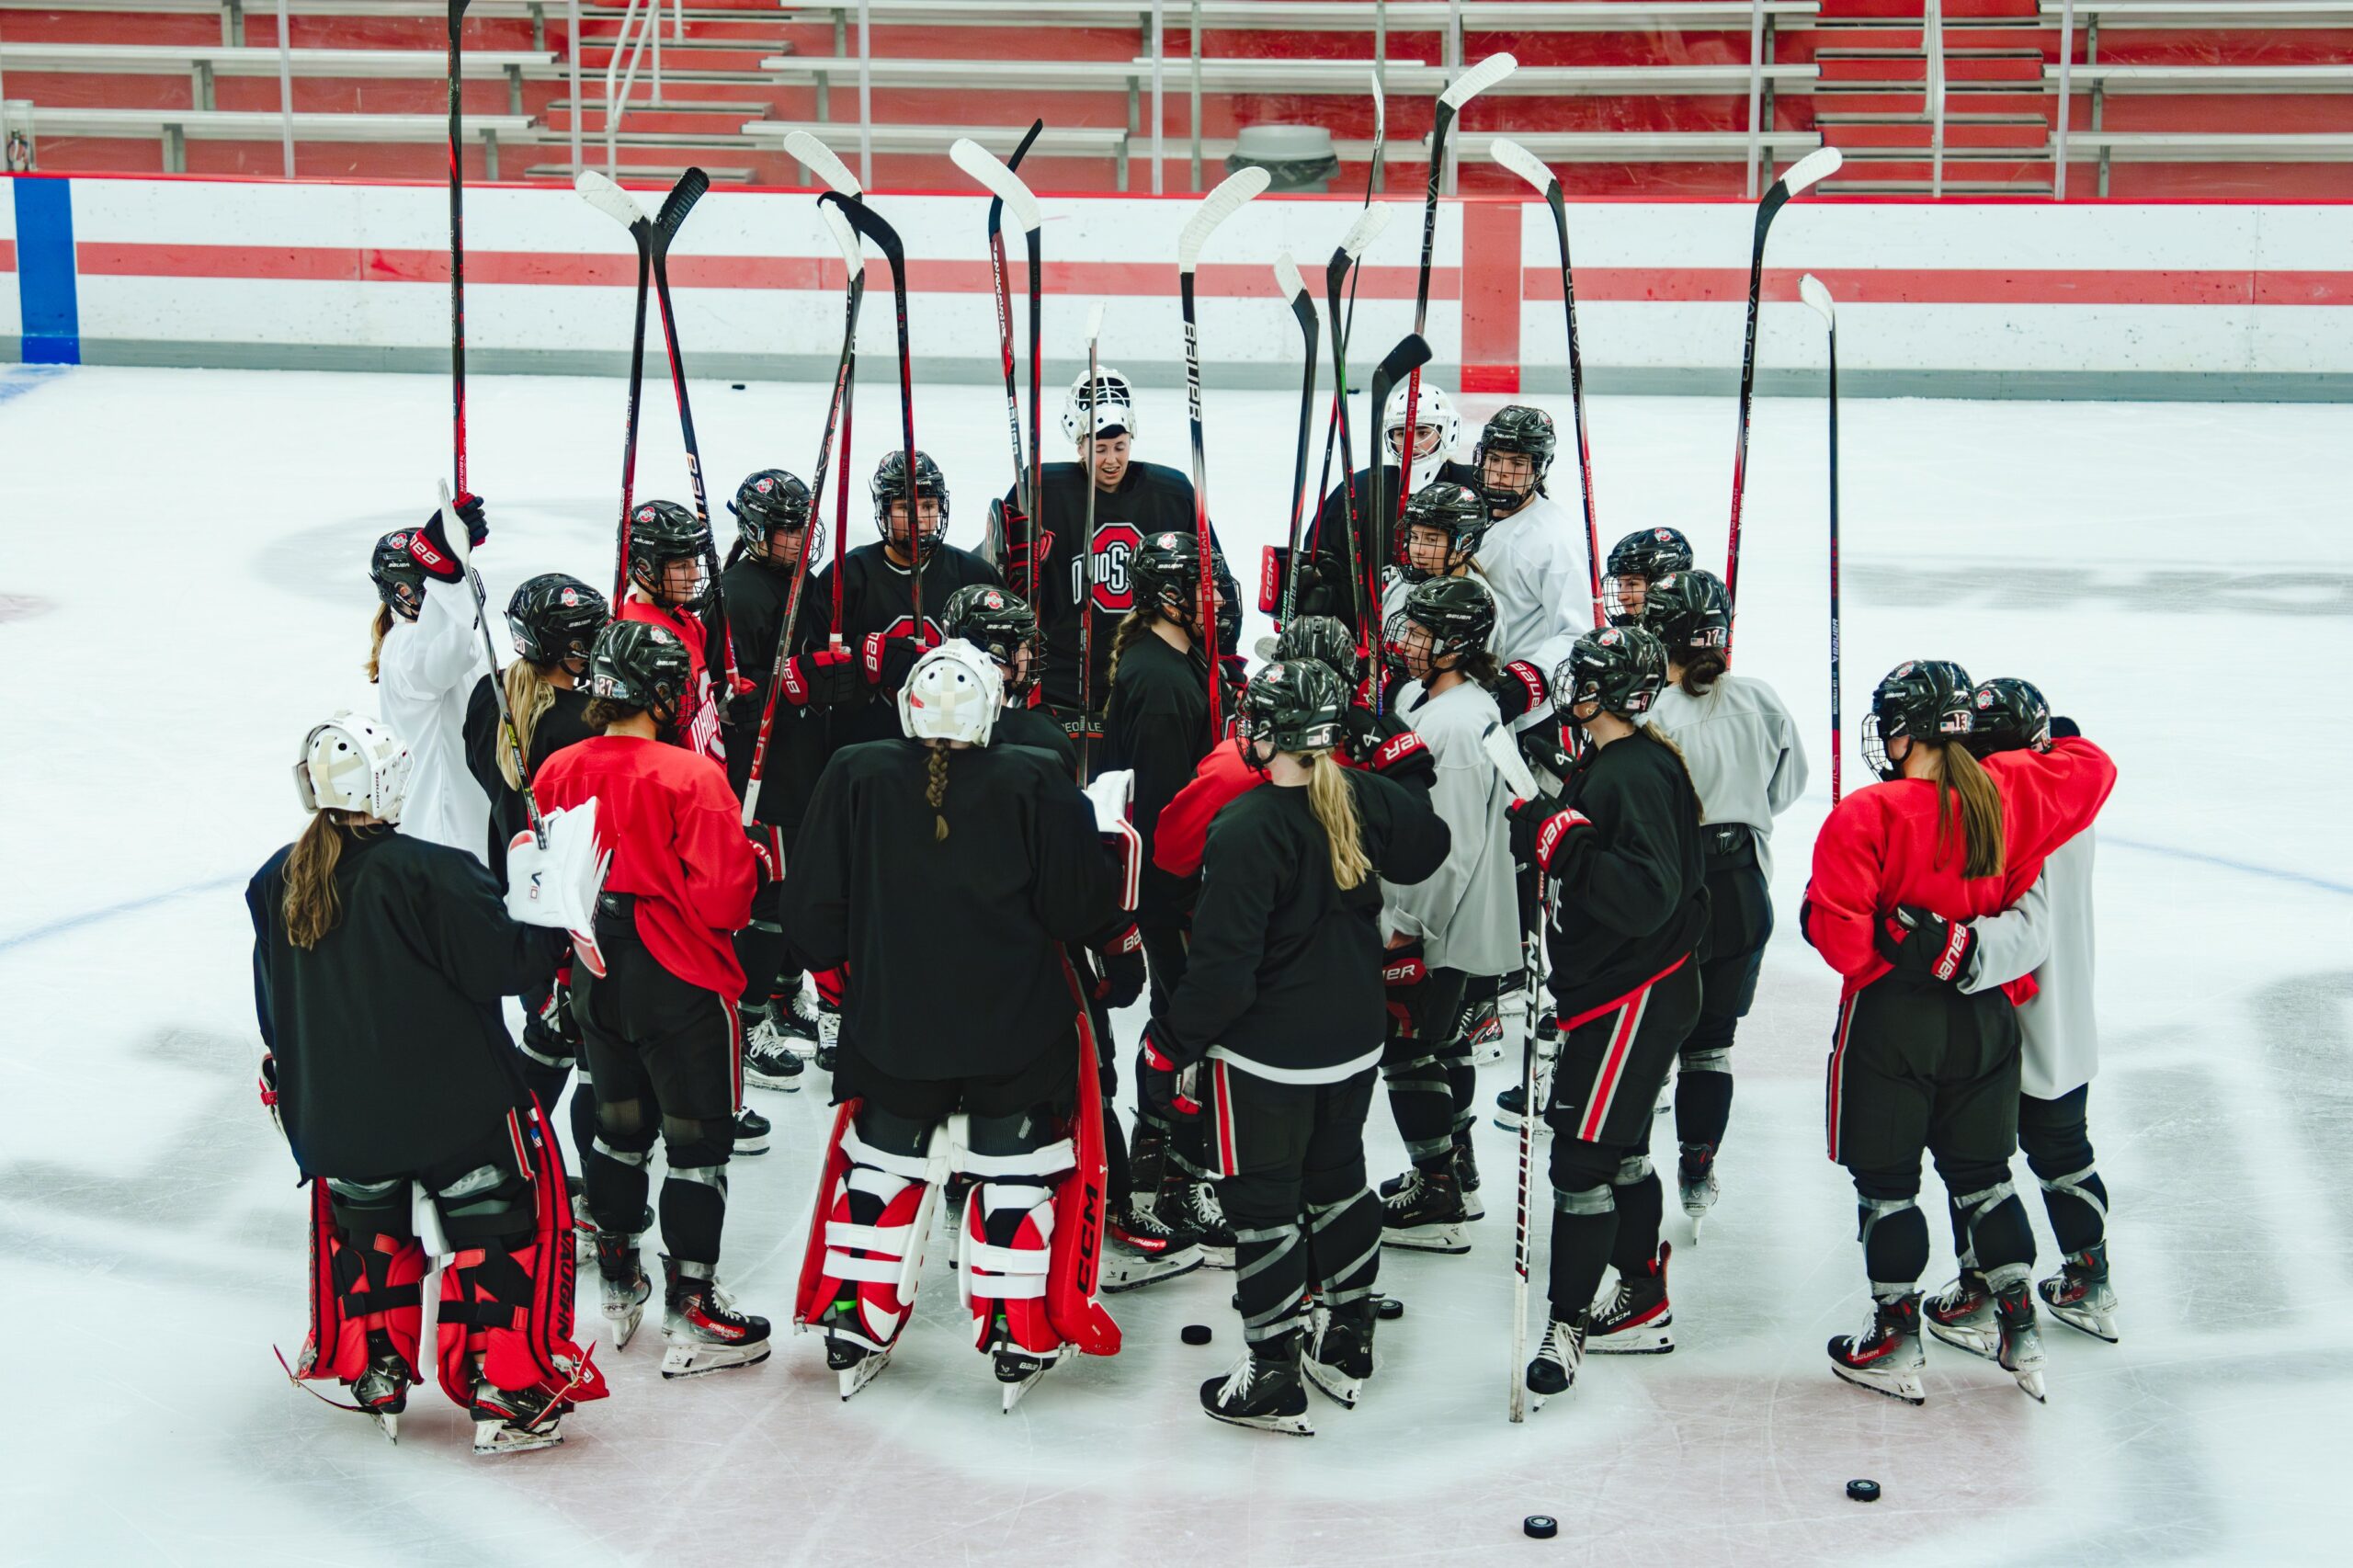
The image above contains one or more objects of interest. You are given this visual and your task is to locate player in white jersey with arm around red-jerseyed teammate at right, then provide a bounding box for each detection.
[1901,678,2115,1356]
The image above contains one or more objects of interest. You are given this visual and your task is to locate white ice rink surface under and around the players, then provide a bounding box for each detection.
[0,368,2353,1568]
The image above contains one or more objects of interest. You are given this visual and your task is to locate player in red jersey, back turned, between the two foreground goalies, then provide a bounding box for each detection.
[537,621,774,1378]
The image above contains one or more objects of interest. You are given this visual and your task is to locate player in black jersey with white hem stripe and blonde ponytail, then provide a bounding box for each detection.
[1136,662,1447,1434]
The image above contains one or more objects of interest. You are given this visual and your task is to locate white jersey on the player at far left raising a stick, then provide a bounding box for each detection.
[377,579,489,859]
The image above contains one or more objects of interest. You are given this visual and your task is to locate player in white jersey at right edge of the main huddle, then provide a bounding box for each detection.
[1628,570,1805,1243]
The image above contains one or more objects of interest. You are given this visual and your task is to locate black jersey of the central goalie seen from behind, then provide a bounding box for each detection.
[783,739,1118,1081]
